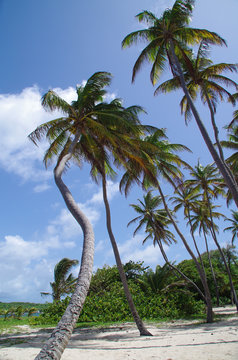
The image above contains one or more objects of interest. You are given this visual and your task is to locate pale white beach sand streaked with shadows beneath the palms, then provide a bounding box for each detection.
[0,307,238,360]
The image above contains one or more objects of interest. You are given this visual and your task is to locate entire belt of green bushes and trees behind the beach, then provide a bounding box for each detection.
[31,252,238,324]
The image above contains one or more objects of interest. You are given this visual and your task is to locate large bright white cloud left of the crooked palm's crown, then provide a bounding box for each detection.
[0,86,75,184]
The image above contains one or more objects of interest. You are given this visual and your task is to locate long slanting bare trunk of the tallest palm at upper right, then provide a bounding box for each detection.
[170,40,238,207]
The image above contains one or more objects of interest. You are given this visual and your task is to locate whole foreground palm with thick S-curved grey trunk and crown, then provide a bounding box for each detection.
[29,72,134,359]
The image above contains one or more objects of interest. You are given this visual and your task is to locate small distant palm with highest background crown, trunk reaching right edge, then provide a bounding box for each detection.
[186,163,238,310]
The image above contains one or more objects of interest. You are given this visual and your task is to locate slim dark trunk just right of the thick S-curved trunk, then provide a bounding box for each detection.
[102,174,152,336]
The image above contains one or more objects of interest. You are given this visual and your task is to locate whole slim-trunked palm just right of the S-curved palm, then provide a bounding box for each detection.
[72,99,151,336]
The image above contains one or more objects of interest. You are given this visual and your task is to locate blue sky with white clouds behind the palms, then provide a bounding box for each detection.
[0,0,238,301]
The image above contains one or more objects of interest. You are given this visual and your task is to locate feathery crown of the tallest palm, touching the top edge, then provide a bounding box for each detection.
[122,0,226,84]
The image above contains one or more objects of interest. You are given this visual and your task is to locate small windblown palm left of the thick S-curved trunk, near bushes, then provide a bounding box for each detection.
[41,258,79,301]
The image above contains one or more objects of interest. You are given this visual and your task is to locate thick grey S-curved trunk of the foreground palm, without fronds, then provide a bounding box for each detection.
[35,134,94,360]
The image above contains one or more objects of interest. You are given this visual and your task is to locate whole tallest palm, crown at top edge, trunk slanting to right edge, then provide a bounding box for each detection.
[122,0,238,206]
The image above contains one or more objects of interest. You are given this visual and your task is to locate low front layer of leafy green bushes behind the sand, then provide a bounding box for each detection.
[34,281,204,325]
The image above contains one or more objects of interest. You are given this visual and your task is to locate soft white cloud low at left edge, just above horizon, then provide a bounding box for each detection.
[0,235,62,301]
